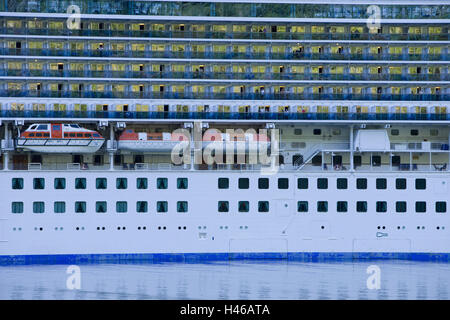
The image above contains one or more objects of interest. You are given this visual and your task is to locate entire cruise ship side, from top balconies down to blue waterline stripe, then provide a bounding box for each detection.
[0,0,450,262]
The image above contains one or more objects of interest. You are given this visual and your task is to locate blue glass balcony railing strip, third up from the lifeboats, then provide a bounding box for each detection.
[0,69,450,81]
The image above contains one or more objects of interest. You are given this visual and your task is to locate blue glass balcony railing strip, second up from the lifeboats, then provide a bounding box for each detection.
[0,90,450,101]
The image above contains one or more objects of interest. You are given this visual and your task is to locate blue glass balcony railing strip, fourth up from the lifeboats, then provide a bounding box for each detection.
[0,47,450,61]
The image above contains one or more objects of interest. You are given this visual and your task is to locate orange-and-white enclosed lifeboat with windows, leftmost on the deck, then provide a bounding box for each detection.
[16,123,105,153]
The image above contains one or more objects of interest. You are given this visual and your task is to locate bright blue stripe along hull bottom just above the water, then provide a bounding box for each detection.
[0,252,450,265]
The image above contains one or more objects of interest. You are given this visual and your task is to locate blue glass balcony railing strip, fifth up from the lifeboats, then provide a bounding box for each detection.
[0,25,450,41]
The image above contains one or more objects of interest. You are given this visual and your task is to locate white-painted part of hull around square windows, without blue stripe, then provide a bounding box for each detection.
[0,171,450,256]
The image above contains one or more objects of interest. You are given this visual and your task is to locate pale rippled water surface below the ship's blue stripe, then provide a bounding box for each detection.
[0,261,450,300]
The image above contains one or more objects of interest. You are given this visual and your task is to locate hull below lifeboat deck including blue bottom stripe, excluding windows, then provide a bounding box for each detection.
[0,171,450,263]
